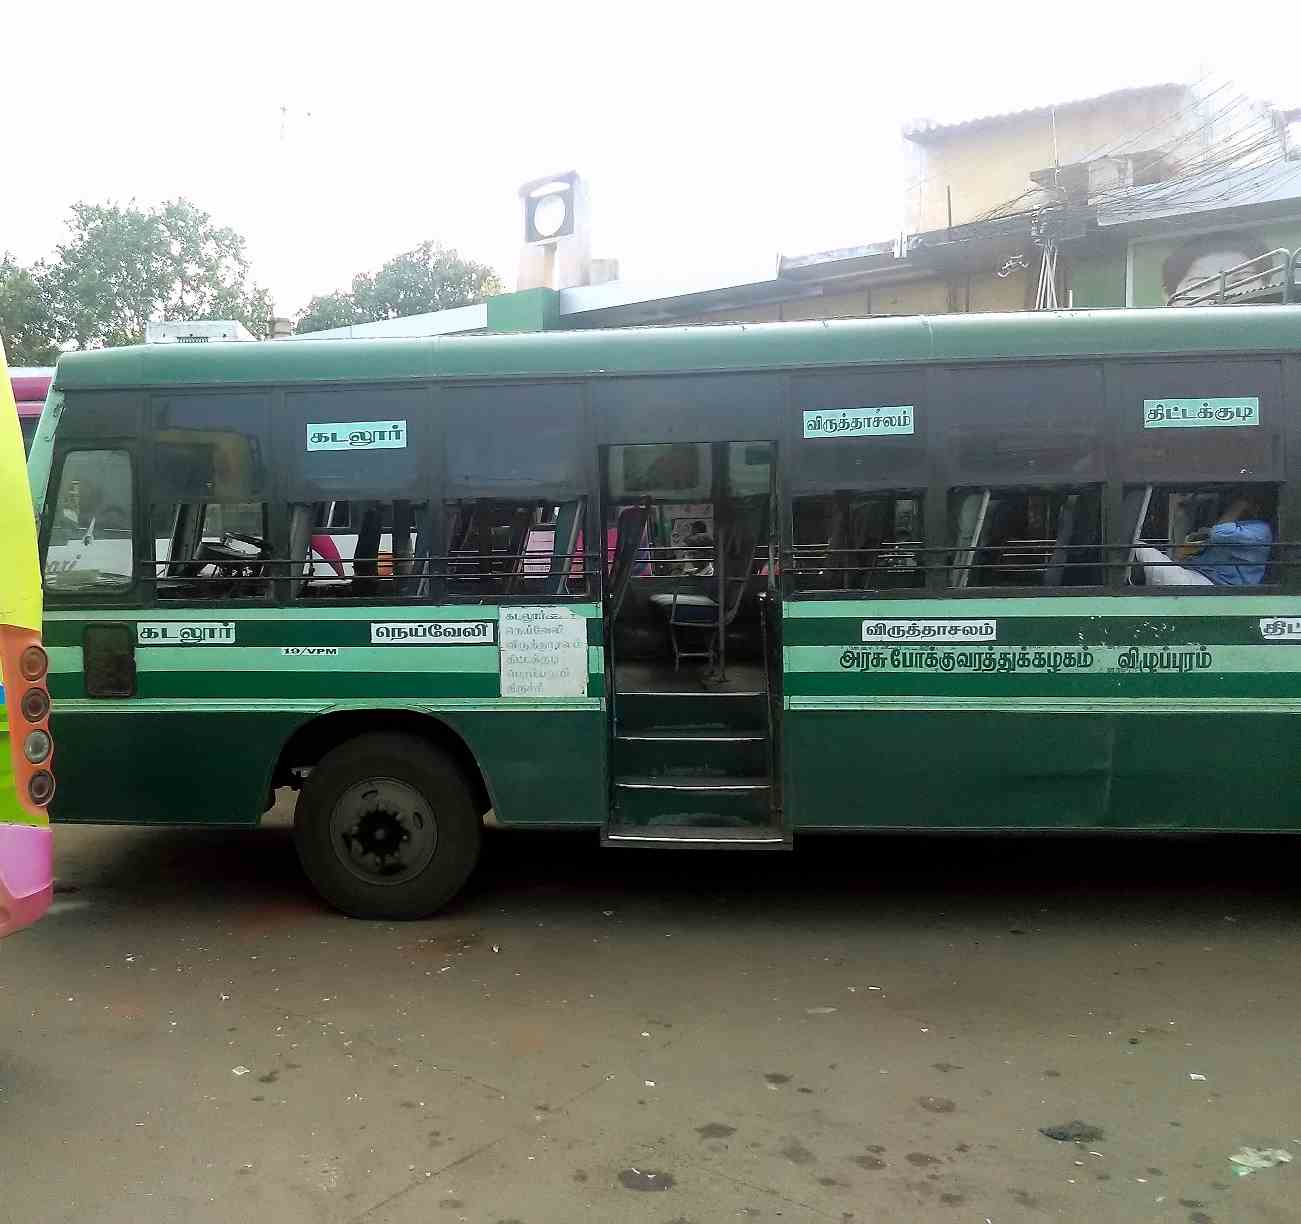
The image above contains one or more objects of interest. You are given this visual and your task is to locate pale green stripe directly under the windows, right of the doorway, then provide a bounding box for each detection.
[782,593,1301,620]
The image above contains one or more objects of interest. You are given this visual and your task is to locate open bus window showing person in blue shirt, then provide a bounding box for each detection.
[1133,485,1274,587]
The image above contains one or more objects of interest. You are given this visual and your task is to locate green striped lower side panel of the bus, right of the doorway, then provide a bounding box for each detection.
[783,593,1301,831]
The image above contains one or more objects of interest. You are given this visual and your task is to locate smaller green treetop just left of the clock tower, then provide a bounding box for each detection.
[297,242,501,333]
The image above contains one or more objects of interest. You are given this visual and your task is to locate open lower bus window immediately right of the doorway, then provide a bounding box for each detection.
[791,492,926,591]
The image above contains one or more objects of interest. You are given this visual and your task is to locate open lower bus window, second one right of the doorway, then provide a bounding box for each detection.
[948,488,1102,588]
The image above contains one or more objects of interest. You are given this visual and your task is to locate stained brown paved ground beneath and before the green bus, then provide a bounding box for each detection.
[0,801,1301,1224]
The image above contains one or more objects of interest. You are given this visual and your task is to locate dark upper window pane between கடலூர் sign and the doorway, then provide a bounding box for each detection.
[442,384,584,494]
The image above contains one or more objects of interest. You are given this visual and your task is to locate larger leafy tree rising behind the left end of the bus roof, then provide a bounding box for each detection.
[44,199,272,349]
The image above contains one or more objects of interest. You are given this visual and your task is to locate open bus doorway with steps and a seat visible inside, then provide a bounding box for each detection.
[602,441,788,848]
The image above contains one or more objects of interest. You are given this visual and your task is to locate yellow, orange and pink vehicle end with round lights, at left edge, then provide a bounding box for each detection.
[0,349,55,937]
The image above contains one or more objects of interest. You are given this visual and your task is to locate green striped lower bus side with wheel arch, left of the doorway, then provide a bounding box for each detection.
[46,605,608,825]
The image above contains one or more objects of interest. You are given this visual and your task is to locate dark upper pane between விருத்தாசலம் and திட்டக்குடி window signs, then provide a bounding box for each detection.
[938,364,1106,484]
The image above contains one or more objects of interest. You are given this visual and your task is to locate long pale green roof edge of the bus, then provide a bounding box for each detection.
[55,306,1301,390]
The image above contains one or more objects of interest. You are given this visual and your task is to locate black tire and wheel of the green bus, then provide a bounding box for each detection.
[294,734,481,920]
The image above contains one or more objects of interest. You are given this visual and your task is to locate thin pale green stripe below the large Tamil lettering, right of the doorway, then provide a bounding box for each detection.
[785,696,1301,714]
